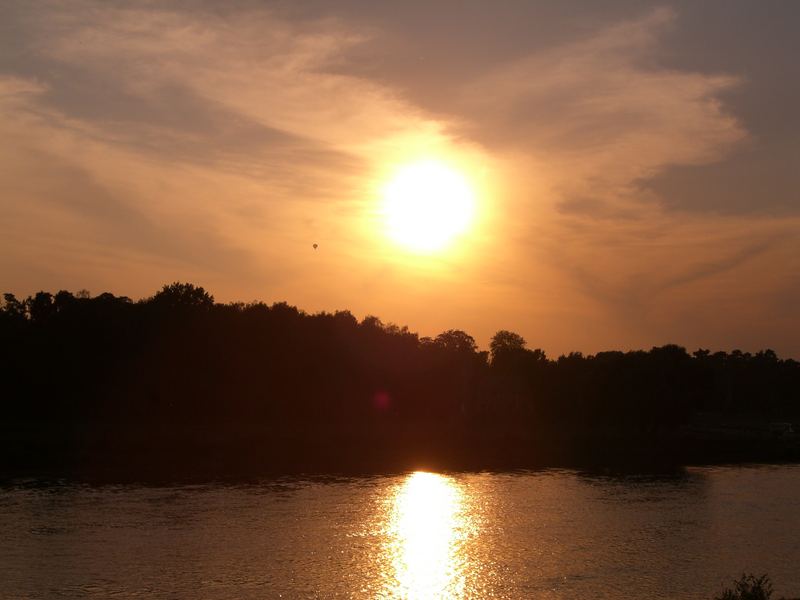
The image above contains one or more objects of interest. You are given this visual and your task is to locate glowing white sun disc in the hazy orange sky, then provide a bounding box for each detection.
[383,160,475,253]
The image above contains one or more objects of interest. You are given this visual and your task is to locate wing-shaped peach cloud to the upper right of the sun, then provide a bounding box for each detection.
[455,9,746,210]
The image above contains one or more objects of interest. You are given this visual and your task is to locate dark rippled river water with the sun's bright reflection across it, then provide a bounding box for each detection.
[0,466,800,599]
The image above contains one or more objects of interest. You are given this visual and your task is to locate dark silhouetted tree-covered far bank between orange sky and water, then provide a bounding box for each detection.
[0,283,800,474]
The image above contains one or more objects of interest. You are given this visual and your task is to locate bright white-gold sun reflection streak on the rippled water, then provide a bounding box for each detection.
[386,471,469,598]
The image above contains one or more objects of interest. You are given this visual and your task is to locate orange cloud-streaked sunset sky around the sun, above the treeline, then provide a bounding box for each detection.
[0,0,800,358]
